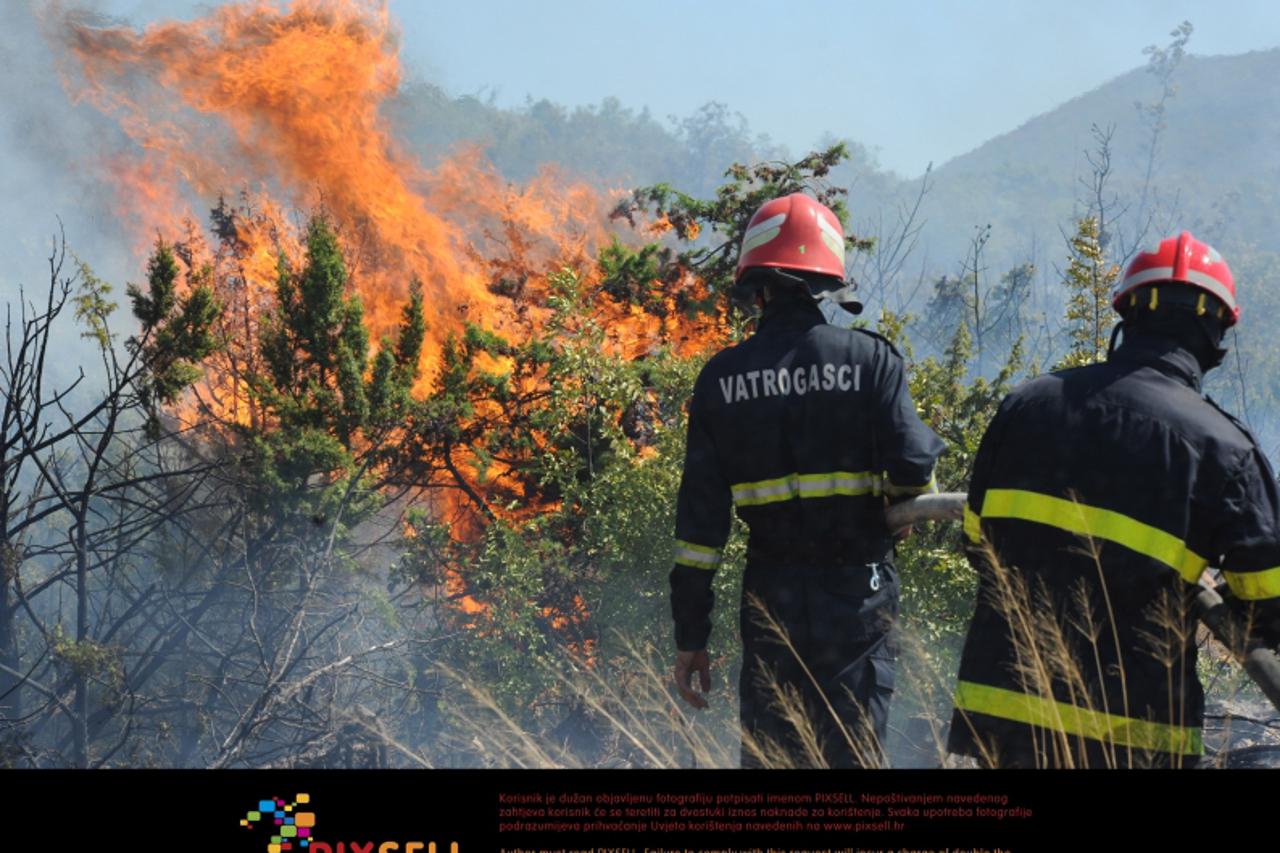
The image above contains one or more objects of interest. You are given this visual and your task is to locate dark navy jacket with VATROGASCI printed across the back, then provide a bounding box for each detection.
[671,297,943,651]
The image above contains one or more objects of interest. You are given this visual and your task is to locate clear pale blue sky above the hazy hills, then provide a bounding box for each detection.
[70,0,1280,175]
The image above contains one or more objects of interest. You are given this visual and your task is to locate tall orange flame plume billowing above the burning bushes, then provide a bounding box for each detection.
[57,0,616,370]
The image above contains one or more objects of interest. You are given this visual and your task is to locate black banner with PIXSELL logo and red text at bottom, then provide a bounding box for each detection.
[3,770,1259,853]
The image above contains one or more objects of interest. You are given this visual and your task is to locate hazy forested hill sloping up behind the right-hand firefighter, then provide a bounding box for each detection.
[896,50,1280,450]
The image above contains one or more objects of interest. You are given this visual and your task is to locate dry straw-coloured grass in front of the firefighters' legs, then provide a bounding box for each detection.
[414,514,1274,768]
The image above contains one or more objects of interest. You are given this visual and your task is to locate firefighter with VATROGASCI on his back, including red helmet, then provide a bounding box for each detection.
[671,193,943,767]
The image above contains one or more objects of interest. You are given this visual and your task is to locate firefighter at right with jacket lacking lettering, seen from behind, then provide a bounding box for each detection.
[948,232,1280,767]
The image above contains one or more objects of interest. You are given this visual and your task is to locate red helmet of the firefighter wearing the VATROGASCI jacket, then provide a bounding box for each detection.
[733,192,845,283]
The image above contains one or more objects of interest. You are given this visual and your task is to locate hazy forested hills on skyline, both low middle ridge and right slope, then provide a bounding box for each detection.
[392,49,1280,450]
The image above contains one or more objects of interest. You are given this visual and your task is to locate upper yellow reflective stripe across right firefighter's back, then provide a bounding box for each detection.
[982,489,1208,584]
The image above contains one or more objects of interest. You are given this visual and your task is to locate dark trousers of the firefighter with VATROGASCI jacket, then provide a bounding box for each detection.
[739,562,899,767]
